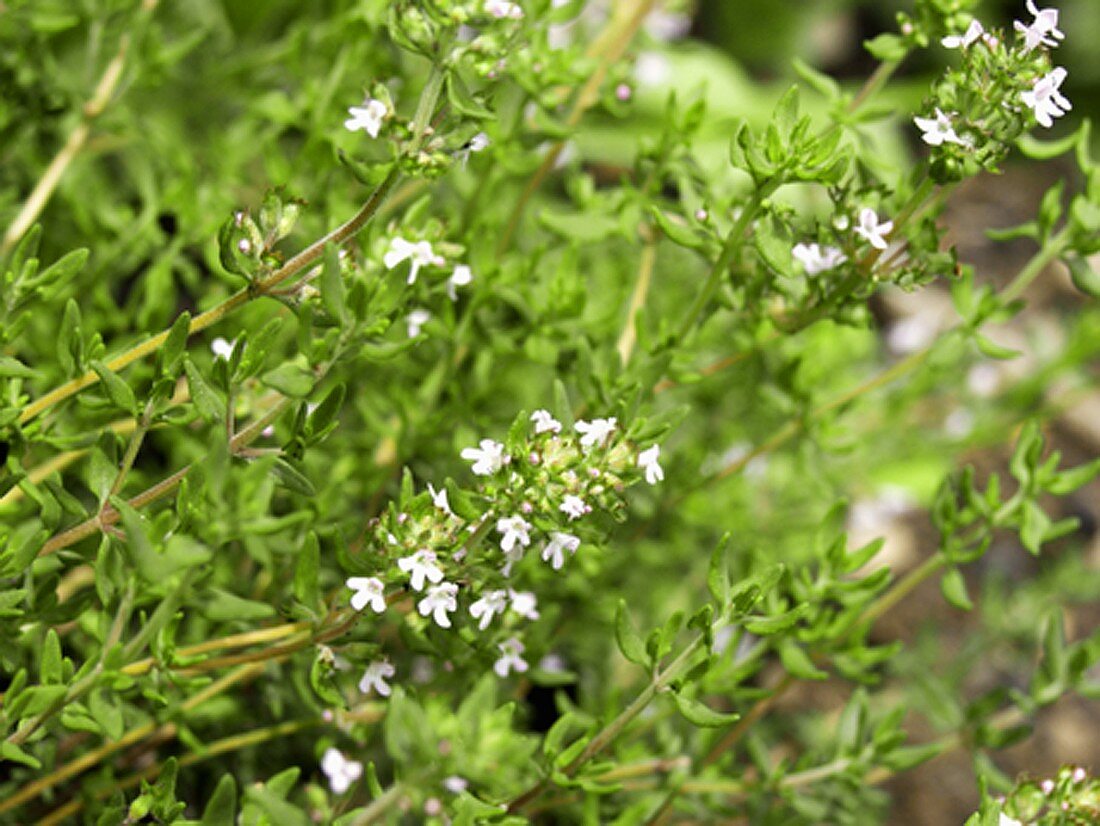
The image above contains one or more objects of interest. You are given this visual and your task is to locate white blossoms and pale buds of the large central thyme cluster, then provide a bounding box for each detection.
[333,410,664,695]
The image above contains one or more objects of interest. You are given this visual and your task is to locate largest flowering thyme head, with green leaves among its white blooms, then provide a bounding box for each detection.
[336,410,664,696]
